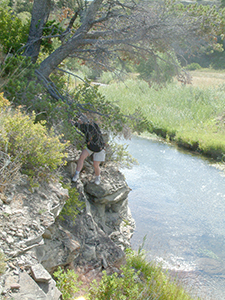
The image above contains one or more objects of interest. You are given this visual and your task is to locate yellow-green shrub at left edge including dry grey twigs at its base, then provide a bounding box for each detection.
[0,94,68,192]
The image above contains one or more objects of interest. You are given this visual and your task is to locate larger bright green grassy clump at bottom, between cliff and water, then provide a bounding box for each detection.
[86,251,197,300]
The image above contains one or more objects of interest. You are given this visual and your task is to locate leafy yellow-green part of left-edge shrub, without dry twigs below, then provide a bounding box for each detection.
[0,101,67,182]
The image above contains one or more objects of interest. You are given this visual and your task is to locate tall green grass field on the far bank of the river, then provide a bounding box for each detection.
[100,80,225,158]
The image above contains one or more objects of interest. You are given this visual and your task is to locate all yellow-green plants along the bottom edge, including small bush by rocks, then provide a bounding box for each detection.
[54,250,196,300]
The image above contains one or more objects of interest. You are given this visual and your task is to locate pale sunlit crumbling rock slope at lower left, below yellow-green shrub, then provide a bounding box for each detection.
[0,177,68,299]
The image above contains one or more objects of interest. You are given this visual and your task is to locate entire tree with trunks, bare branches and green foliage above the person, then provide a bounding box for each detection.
[2,0,225,150]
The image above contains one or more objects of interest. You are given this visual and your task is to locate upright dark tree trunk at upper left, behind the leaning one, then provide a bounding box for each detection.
[24,0,51,63]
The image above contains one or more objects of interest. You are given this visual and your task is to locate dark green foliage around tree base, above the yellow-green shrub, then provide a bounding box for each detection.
[2,55,65,125]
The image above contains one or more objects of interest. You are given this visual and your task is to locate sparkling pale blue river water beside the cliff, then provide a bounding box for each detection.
[122,137,225,300]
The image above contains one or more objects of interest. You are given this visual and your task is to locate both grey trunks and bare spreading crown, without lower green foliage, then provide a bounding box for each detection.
[22,0,224,85]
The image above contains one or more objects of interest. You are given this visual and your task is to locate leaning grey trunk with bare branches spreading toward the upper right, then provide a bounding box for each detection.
[25,0,221,78]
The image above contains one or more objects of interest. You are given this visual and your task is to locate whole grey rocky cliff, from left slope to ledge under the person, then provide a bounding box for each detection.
[0,151,135,299]
